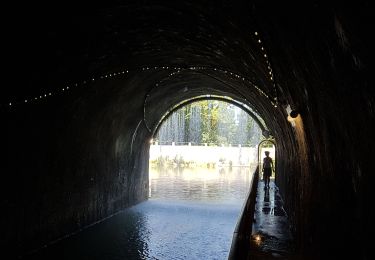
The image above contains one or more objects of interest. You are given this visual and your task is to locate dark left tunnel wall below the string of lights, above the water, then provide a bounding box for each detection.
[2,78,150,255]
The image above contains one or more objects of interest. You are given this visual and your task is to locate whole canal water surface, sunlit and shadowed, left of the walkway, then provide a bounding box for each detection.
[25,167,255,260]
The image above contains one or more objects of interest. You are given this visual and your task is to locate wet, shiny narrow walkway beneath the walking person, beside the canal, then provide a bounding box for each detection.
[250,180,295,259]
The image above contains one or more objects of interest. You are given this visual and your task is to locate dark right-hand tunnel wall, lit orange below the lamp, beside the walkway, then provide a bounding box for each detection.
[257,2,374,259]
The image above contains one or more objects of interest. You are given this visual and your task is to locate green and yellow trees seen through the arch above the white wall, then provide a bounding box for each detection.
[158,100,261,145]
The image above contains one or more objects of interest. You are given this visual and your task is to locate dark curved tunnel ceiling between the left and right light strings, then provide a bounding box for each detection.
[2,3,286,136]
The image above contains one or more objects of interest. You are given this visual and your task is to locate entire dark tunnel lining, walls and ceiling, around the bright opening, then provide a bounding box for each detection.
[1,0,375,259]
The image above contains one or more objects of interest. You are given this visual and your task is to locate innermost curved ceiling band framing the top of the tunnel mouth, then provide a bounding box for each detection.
[143,67,280,144]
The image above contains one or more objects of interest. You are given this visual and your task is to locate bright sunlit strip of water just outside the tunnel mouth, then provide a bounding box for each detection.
[150,167,252,204]
